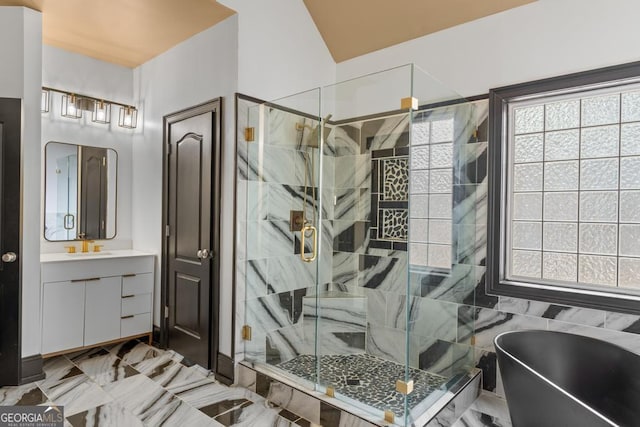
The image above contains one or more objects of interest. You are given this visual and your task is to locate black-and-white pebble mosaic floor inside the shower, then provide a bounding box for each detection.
[276,354,448,417]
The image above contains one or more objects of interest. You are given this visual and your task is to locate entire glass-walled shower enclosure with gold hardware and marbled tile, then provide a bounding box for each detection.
[236,65,486,426]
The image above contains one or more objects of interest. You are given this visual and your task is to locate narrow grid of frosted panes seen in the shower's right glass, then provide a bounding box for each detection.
[409,115,454,269]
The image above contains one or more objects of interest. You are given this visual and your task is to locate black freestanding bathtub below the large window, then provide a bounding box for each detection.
[495,330,640,427]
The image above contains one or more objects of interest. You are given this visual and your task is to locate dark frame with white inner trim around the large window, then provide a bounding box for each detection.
[486,61,640,314]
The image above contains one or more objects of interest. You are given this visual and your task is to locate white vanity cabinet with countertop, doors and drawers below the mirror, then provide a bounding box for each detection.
[41,250,154,356]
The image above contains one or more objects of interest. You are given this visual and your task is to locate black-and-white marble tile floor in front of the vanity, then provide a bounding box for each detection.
[0,340,311,427]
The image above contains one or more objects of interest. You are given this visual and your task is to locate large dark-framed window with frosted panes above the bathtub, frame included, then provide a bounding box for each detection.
[487,63,640,314]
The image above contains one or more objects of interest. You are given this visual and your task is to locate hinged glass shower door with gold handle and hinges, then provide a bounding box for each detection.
[242,90,322,388]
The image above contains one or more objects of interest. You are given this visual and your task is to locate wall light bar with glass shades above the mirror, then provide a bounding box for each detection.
[41,86,138,129]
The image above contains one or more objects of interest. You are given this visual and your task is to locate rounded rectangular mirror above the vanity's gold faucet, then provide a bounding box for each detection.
[44,141,118,241]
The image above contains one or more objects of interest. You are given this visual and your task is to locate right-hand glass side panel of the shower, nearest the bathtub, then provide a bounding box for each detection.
[406,67,478,425]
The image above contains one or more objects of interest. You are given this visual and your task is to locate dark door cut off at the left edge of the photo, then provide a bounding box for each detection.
[0,98,22,386]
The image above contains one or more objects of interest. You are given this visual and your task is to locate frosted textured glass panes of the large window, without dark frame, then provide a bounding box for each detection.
[506,88,640,289]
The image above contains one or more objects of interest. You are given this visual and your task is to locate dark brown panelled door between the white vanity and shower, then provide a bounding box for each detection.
[164,101,220,368]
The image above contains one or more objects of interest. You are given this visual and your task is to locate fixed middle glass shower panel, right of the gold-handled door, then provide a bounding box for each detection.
[317,66,411,421]
